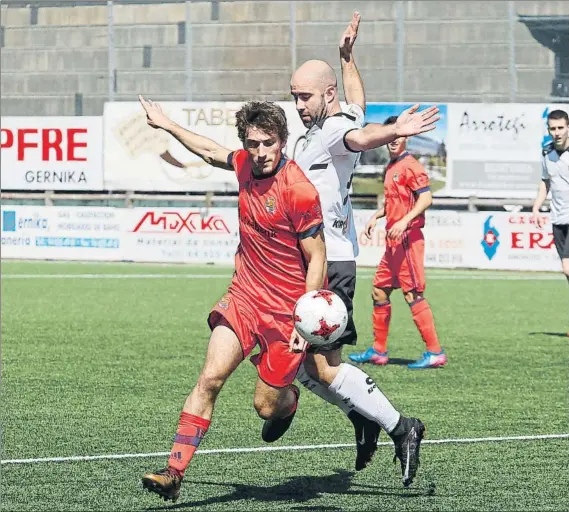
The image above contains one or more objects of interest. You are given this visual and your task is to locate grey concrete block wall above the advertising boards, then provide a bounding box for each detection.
[0,0,569,115]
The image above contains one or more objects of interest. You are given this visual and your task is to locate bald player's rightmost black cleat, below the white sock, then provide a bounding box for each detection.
[391,416,425,487]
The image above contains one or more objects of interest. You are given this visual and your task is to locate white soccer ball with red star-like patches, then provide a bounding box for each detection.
[294,290,348,346]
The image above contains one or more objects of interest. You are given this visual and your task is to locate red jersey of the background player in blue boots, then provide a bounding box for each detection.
[383,152,430,229]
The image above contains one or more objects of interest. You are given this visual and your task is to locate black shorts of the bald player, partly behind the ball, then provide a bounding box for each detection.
[308,261,358,352]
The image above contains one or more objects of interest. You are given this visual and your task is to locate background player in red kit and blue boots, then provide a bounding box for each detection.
[349,116,447,369]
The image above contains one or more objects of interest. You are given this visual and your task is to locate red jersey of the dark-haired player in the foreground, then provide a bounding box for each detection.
[228,150,324,314]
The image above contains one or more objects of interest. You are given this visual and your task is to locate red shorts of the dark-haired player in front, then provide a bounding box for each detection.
[208,293,305,388]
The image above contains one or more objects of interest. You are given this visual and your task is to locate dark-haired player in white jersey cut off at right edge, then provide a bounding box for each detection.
[533,110,569,336]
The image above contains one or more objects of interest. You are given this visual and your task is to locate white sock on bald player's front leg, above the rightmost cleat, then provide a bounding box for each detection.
[327,363,401,433]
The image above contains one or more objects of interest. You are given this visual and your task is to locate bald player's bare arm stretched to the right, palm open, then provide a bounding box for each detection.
[344,104,440,152]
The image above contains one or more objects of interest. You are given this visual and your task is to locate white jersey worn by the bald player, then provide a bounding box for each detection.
[295,105,364,261]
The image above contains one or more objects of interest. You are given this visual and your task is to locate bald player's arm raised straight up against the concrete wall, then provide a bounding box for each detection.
[340,11,366,112]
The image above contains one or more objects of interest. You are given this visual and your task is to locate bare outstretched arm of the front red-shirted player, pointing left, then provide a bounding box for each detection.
[138,95,233,170]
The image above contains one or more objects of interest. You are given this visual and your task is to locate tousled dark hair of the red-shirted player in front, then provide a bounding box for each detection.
[235,101,288,144]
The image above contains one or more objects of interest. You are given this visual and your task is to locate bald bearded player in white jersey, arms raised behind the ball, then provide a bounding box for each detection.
[263,13,439,486]
